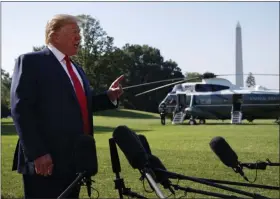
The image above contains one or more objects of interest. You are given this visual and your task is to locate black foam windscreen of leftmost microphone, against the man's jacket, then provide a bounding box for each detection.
[74,135,98,175]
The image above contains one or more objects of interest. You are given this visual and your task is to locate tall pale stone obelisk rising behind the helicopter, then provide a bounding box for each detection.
[235,22,244,87]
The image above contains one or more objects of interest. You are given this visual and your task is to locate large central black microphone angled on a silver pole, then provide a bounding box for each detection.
[113,126,165,198]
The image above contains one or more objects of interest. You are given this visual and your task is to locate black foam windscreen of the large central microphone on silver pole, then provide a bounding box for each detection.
[113,126,148,169]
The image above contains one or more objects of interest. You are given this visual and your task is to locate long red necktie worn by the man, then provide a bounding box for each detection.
[64,55,90,134]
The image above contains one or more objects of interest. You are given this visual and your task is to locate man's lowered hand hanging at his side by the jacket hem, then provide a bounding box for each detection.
[34,154,53,176]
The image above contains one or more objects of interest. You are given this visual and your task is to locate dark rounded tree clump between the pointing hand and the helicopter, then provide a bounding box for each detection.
[117,44,184,112]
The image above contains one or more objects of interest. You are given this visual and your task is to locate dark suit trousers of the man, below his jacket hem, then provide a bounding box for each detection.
[23,175,80,199]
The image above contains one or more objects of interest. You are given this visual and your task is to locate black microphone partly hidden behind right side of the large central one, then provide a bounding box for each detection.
[138,134,175,194]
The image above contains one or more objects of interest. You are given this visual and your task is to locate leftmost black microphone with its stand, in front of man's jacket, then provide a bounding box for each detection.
[58,135,98,199]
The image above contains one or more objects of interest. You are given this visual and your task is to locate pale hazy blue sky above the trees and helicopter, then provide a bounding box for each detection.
[1,2,279,89]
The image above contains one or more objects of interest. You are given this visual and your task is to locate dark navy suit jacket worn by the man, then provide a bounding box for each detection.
[11,48,117,174]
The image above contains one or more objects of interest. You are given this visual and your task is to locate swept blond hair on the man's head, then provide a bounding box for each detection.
[45,14,78,44]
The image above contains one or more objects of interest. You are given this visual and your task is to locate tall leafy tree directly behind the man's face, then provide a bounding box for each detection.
[73,15,115,90]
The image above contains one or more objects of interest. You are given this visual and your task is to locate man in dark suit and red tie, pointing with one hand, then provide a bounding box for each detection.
[11,15,123,198]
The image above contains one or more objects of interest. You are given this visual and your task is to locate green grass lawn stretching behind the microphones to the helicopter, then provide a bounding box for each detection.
[1,110,279,198]
